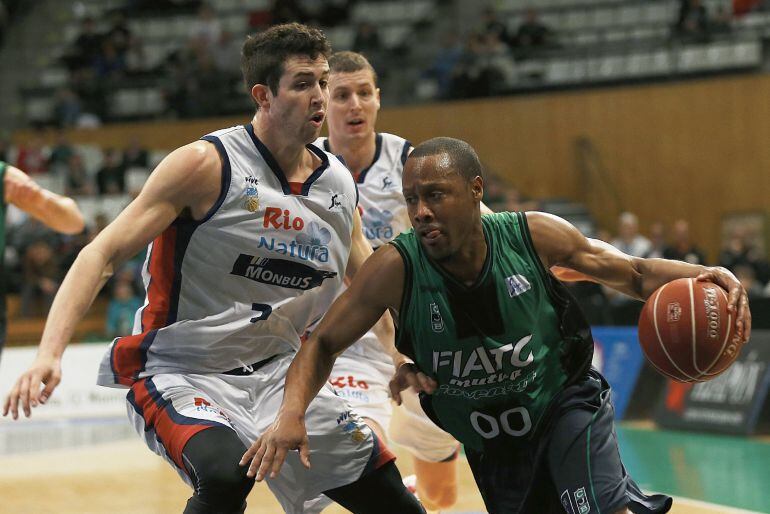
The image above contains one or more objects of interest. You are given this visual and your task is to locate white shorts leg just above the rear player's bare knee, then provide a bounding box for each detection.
[388,389,459,462]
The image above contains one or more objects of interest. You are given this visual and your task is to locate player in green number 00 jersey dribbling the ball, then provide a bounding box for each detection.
[241,138,751,514]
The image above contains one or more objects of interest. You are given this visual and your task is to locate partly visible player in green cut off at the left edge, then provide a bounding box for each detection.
[0,161,85,351]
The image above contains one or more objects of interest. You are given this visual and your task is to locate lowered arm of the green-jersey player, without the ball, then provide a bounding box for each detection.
[240,245,404,481]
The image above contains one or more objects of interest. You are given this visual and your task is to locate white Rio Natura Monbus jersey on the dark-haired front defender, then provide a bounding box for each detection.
[98,124,358,386]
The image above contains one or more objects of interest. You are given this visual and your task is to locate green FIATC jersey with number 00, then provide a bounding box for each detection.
[391,212,593,451]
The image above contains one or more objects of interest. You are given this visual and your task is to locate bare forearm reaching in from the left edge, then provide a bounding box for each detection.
[3,166,85,234]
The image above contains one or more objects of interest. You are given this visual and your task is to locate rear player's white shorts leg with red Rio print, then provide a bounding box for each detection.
[329,353,394,430]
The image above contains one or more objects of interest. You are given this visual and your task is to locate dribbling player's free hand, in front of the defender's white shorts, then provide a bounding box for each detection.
[238,413,310,482]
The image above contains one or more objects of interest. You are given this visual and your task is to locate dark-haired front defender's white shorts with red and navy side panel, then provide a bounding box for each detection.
[127,353,392,514]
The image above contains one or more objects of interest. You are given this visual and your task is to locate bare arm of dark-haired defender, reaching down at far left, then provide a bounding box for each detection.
[3,141,221,419]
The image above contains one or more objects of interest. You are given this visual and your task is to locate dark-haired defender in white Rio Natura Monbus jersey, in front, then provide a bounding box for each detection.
[4,24,424,514]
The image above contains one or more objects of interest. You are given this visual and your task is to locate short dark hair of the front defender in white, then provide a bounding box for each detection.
[241,23,332,108]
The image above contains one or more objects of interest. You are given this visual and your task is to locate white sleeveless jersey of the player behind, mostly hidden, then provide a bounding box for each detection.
[314,133,412,364]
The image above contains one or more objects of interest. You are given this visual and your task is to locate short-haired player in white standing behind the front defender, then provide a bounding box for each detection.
[308,52,459,512]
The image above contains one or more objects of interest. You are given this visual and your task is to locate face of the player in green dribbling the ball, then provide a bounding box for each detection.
[402,154,482,261]
